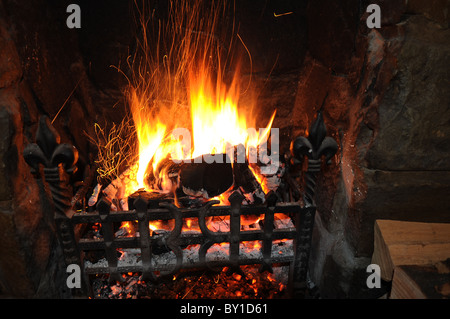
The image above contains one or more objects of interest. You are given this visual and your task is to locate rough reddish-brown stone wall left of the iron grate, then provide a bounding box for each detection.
[0,1,80,297]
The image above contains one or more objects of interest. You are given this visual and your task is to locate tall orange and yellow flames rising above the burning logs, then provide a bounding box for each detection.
[128,0,275,196]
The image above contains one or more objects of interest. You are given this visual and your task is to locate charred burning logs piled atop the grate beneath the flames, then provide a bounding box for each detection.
[89,145,281,210]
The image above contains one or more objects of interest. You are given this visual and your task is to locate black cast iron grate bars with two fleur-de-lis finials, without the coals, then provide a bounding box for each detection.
[24,112,337,297]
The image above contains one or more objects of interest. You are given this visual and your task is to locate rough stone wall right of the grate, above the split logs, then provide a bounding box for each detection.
[302,1,450,298]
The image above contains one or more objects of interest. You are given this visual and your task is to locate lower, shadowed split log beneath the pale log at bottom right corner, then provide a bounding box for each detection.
[390,259,450,299]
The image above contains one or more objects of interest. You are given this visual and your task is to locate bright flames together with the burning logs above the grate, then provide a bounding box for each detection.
[89,1,282,233]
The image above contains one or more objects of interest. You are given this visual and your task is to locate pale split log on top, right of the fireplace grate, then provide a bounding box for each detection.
[372,220,450,281]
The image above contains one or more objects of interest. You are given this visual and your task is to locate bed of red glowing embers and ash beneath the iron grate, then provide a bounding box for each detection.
[94,266,287,299]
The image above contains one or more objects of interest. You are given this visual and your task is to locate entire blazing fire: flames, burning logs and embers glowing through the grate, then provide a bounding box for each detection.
[76,1,294,297]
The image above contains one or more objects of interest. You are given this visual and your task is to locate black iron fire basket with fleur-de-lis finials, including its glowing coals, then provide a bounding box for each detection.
[24,105,338,298]
